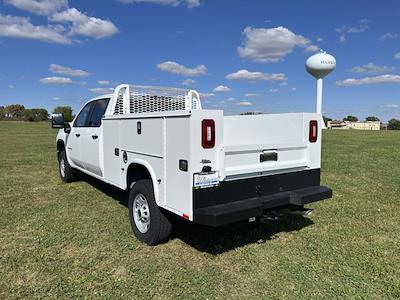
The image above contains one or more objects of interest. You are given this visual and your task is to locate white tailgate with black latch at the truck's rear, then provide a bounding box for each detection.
[223,113,320,179]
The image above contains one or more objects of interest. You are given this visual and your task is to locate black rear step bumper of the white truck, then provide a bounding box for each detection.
[193,169,332,227]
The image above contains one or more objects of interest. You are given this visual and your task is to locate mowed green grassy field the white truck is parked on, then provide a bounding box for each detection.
[0,122,400,299]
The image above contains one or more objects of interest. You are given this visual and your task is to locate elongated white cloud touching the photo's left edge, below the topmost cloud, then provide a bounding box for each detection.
[0,14,72,44]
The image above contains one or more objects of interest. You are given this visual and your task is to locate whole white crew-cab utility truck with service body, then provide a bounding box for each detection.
[52,84,332,245]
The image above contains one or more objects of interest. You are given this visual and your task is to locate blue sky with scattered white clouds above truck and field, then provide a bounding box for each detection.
[0,0,400,121]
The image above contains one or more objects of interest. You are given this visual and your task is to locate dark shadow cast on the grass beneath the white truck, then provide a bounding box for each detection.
[80,174,314,255]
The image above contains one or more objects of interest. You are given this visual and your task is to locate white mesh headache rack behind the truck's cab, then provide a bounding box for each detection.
[108,84,201,115]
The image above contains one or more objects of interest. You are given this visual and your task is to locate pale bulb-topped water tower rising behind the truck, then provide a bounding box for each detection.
[306,50,336,114]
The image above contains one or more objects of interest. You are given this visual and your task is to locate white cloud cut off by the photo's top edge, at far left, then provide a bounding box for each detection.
[5,0,68,16]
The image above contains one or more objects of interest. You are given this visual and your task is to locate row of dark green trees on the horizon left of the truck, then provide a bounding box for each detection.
[0,104,74,122]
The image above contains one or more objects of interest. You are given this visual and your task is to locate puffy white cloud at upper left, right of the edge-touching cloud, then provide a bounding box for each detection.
[49,8,118,39]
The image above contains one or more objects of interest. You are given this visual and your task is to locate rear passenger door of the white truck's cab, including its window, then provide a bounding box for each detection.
[81,98,110,176]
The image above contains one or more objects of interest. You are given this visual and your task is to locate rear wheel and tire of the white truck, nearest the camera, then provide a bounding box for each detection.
[128,179,172,245]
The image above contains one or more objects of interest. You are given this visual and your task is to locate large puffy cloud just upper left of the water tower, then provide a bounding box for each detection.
[238,26,318,63]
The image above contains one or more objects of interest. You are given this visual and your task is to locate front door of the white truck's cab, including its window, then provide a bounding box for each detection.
[67,102,93,168]
